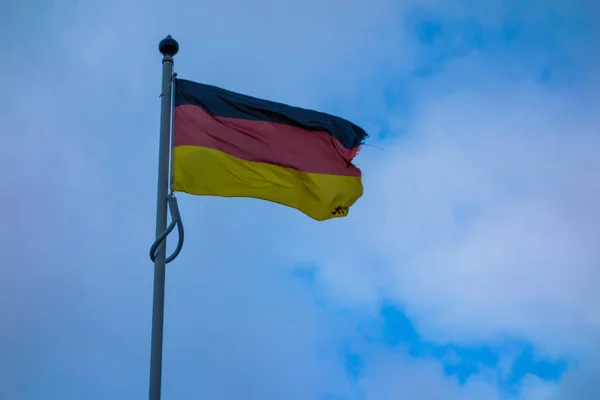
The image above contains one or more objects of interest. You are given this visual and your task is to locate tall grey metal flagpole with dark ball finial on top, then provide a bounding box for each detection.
[150,35,179,400]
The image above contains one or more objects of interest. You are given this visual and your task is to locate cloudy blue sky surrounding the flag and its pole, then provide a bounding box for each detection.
[0,0,600,400]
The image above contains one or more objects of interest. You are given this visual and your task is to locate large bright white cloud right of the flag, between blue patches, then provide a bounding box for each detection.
[328,75,600,351]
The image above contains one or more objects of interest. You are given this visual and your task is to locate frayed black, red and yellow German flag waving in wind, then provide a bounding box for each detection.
[173,79,367,221]
